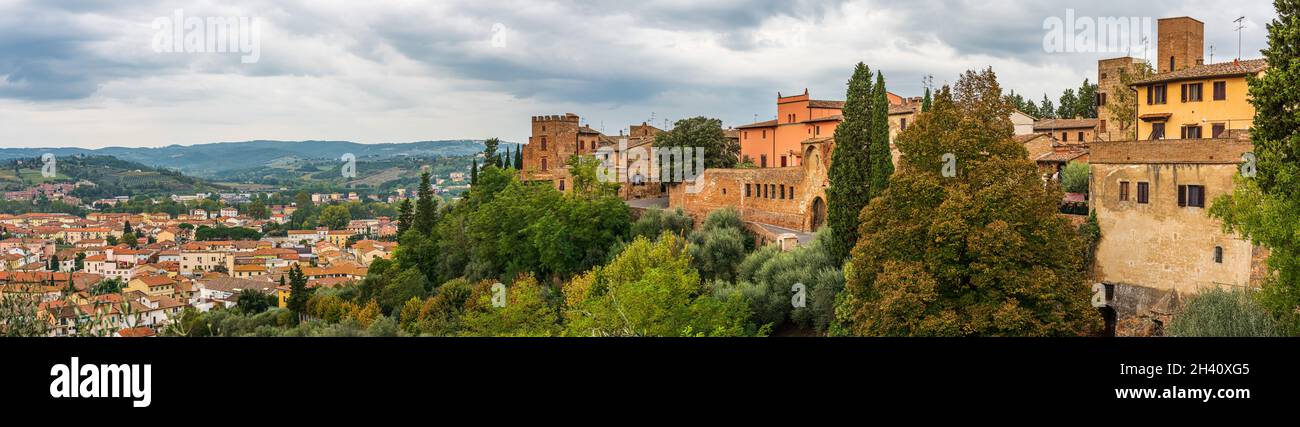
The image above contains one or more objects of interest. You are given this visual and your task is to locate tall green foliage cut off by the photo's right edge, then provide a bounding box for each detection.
[1210,0,1300,336]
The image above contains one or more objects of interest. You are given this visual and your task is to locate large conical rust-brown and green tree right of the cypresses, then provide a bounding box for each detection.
[835,69,1100,336]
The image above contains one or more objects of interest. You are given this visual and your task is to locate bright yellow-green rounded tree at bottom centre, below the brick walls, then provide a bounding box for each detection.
[564,234,768,336]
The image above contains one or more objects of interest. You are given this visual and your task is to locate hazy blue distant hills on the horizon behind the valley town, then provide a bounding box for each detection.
[0,139,516,178]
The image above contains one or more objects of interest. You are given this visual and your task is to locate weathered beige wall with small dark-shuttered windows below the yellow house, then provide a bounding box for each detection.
[1089,139,1258,293]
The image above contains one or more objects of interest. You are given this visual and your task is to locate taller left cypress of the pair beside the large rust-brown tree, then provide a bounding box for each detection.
[826,62,872,263]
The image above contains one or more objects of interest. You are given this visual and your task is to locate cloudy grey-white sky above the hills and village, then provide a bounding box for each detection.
[0,0,1275,147]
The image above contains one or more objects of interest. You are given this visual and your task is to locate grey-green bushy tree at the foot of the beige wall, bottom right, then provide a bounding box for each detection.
[1165,288,1278,337]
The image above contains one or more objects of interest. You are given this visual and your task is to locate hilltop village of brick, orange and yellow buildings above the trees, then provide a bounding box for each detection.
[521,17,1268,335]
